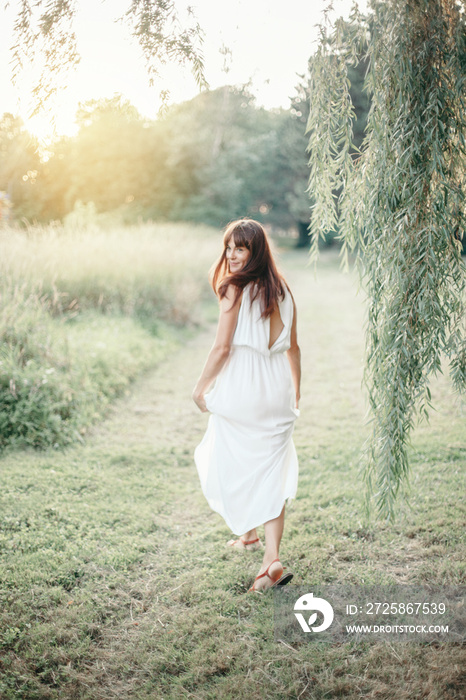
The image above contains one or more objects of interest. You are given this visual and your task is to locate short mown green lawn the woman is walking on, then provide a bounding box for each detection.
[0,253,466,700]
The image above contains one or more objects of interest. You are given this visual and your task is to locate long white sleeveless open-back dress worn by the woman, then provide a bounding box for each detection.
[194,284,299,535]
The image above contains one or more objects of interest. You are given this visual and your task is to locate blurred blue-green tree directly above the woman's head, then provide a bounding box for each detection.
[158,85,292,226]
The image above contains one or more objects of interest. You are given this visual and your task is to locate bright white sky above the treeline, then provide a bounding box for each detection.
[0,0,367,139]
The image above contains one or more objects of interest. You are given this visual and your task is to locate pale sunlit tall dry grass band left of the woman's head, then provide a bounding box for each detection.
[0,223,221,324]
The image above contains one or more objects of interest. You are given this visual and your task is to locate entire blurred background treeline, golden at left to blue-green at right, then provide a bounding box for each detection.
[0,56,369,238]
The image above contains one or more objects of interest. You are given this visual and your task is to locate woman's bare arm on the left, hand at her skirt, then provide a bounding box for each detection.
[192,284,241,413]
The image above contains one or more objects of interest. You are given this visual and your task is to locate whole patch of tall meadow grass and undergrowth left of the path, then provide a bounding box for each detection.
[0,224,219,449]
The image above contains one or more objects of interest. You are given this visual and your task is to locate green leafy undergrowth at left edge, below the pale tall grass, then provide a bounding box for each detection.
[0,288,175,449]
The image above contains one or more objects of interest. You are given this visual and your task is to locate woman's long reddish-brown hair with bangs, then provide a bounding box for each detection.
[212,219,287,318]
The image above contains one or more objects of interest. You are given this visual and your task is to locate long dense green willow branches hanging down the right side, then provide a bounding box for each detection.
[309,0,466,518]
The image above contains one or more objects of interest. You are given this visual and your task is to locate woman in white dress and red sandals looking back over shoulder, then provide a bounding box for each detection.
[193,219,301,592]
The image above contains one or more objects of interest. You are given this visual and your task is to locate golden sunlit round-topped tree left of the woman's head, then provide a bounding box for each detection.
[38,95,182,220]
